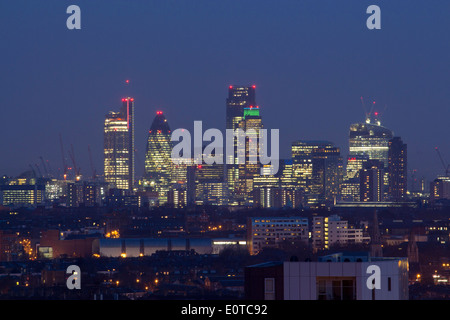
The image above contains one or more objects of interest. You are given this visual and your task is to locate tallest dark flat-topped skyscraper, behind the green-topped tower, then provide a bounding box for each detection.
[226,86,256,204]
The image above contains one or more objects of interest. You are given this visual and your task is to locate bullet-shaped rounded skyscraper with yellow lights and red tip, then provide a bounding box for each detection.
[144,111,173,204]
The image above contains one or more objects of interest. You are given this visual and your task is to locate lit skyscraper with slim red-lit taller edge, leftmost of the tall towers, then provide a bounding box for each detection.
[104,98,135,190]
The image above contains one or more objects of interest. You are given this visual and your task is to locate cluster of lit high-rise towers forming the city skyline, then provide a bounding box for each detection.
[104,86,407,207]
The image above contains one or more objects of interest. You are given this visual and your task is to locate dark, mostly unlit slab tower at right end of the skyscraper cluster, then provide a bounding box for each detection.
[388,137,408,201]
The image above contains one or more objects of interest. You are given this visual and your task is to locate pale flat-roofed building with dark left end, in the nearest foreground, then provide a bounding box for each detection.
[245,254,409,300]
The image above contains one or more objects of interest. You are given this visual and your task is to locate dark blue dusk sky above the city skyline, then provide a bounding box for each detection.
[0,0,450,184]
